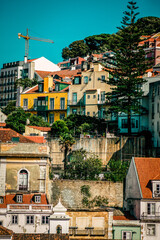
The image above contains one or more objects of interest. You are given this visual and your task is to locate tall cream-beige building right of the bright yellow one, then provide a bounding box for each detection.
[68,63,111,118]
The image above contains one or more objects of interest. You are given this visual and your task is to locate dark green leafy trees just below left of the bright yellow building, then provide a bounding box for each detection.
[6,107,49,134]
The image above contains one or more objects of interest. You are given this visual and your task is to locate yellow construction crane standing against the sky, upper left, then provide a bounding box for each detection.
[18,28,53,59]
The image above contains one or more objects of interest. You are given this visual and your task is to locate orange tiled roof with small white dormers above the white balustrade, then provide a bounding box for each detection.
[0,193,48,208]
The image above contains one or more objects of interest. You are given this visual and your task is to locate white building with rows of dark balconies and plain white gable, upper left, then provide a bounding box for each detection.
[0,57,60,107]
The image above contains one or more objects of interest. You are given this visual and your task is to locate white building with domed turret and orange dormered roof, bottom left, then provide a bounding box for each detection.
[0,193,70,234]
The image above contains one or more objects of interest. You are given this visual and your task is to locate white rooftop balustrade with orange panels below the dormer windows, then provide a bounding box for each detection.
[7,204,52,212]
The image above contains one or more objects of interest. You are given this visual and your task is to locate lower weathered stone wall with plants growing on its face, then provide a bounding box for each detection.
[48,179,123,208]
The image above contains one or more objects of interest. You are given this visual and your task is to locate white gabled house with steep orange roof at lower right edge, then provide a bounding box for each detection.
[124,158,160,240]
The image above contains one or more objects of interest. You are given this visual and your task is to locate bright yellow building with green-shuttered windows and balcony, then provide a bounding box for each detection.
[20,77,70,124]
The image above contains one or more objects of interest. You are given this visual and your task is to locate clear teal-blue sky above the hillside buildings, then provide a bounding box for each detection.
[0,0,160,68]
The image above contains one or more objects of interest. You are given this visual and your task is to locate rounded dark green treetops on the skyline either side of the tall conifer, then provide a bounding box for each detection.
[62,16,160,60]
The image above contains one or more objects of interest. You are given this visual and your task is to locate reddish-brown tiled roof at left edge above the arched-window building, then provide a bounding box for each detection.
[0,128,33,143]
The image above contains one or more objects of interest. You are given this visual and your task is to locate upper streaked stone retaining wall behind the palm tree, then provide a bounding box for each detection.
[49,137,145,165]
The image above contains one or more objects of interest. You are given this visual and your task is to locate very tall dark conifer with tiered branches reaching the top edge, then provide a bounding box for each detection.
[107,1,152,135]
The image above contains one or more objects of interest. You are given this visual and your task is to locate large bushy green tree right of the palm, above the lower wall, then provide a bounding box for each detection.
[67,149,102,180]
